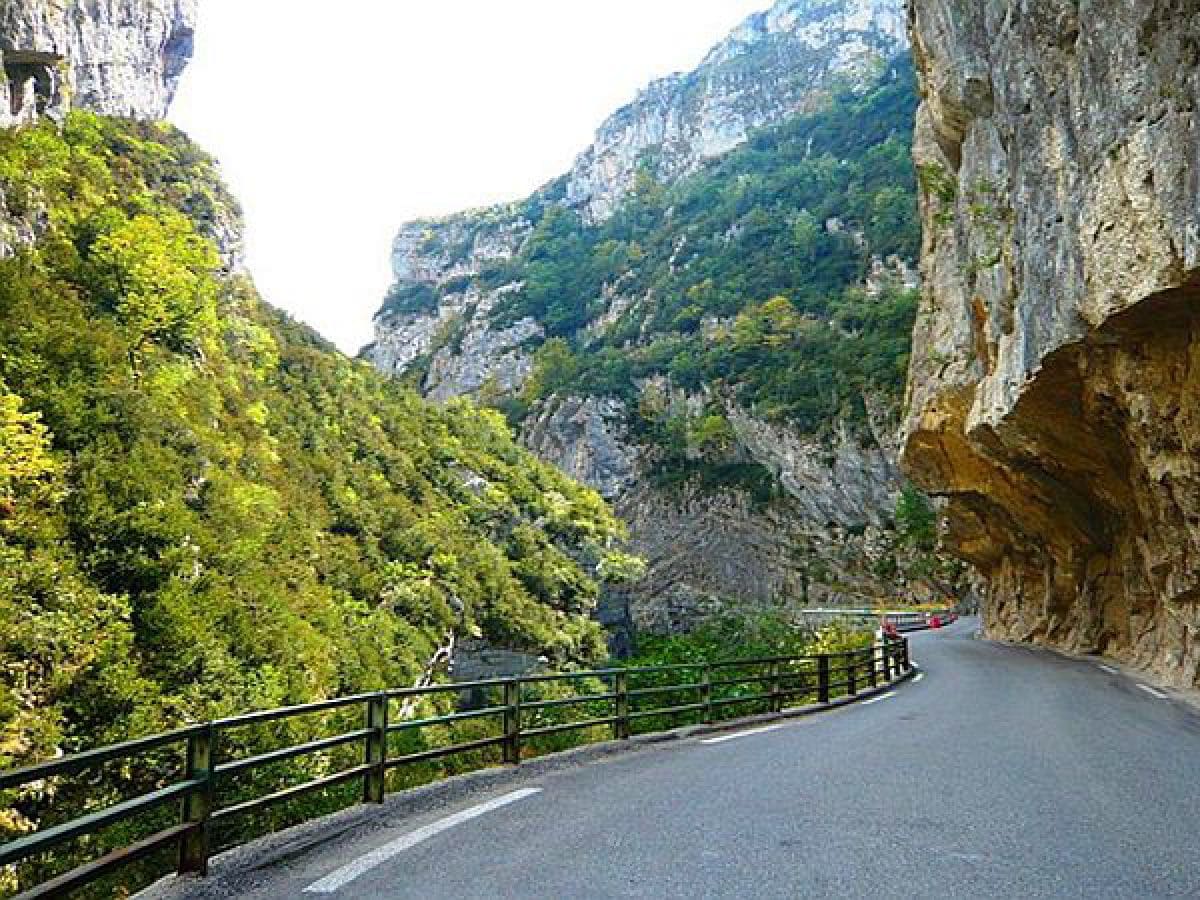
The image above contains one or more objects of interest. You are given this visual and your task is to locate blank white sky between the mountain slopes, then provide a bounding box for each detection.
[170,0,770,353]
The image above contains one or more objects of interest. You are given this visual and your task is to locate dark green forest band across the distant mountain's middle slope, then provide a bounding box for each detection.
[383,61,919,432]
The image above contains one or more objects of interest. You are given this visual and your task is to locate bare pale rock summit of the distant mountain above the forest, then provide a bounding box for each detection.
[566,0,907,222]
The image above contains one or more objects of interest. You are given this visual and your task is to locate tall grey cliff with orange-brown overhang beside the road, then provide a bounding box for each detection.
[905,0,1200,686]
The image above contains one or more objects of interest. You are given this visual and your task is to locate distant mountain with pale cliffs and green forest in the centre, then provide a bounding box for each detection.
[365,2,964,648]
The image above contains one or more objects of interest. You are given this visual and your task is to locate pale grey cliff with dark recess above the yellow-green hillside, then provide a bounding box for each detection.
[0,0,196,127]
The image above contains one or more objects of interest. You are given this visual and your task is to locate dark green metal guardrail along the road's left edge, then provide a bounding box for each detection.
[0,638,912,900]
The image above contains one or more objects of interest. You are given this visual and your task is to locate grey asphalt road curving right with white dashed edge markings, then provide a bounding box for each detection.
[154,620,1200,900]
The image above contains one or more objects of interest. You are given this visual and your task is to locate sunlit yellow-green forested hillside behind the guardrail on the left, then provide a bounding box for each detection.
[0,113,629,782]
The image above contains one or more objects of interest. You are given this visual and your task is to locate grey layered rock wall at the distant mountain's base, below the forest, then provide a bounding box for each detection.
[522,382,926,647]
